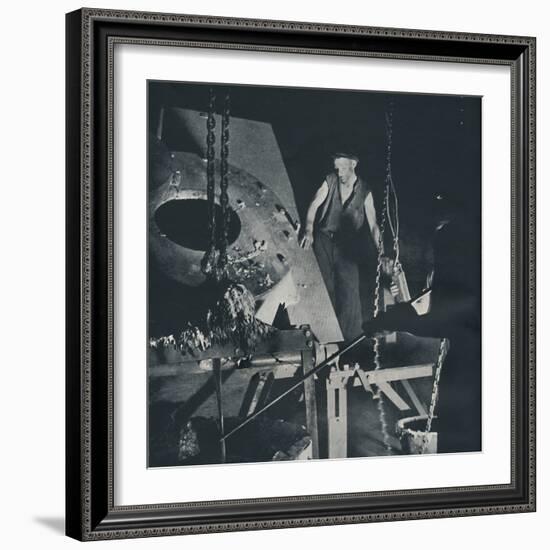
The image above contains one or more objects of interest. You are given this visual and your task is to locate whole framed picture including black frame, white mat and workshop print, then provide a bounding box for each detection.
[67,9,535,540]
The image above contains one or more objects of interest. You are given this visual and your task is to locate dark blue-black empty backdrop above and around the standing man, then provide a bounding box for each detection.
[148,81,481,316]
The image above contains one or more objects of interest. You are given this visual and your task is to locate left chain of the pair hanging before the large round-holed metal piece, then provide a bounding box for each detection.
[201,88,216,275]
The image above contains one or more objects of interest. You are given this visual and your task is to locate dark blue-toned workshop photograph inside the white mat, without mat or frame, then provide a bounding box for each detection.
[147,80,484,468]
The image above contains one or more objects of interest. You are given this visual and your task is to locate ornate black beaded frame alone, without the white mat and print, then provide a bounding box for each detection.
[66,9,535,540]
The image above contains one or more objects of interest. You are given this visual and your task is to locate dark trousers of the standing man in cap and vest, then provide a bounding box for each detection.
[313,231,363,340]
